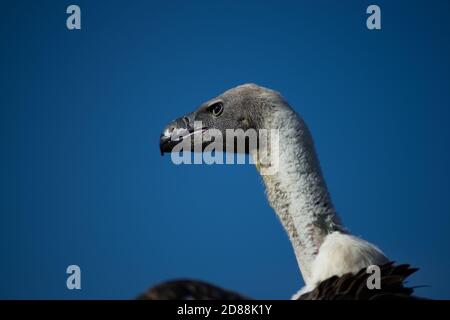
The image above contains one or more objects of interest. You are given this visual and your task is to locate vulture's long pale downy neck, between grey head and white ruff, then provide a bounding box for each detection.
[253,106,343,284]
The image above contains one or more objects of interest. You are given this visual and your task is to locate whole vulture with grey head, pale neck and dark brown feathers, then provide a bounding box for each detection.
[147,84,417,300]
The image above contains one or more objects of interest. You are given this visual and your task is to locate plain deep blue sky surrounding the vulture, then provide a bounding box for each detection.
[0,1,450,299]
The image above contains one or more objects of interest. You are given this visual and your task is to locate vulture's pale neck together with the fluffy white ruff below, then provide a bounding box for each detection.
[251,97,388,298]
